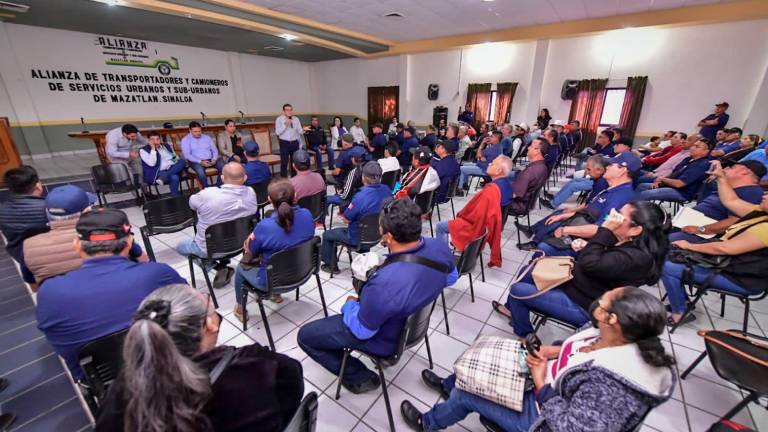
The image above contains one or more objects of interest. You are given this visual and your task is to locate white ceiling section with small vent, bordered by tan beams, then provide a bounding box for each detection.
[246,0,733,41]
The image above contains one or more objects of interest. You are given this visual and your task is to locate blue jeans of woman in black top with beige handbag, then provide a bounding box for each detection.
[505,274,589,337]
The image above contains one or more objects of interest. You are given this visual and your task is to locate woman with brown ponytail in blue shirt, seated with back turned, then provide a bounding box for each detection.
[234,179,315,321]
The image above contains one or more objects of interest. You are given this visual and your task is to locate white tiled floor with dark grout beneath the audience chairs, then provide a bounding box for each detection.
[109,176,768,432]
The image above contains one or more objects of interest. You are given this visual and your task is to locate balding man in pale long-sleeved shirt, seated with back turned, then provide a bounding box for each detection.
[176,162,258,288]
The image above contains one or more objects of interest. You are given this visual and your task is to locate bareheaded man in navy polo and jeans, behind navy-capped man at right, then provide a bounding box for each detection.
[637,138,711,202]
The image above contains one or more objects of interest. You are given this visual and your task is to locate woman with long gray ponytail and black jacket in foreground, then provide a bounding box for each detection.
[96,284,304,432]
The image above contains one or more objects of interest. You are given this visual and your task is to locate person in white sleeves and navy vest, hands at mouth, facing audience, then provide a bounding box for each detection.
[139,131,187,197]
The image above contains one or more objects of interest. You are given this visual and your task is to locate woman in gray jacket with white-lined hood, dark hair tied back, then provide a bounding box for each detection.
[400,287,676,432]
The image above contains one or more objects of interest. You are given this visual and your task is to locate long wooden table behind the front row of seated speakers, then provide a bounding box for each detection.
[67,123,280,167]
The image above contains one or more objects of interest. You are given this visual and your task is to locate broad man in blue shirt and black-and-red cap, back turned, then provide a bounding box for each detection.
[37,209,187,380]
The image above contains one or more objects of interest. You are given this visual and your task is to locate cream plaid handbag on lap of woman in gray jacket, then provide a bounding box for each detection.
[453,336,528,412]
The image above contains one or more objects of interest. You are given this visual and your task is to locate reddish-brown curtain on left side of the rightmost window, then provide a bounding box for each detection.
[568,79,608,151]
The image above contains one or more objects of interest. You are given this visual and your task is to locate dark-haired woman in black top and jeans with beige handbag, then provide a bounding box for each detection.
[492,201,670,337]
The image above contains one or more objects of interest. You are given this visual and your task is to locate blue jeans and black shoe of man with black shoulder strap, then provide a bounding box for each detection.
[297,315,384,385]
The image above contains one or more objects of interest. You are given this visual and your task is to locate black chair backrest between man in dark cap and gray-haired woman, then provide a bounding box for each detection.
[77,329,128,406]
